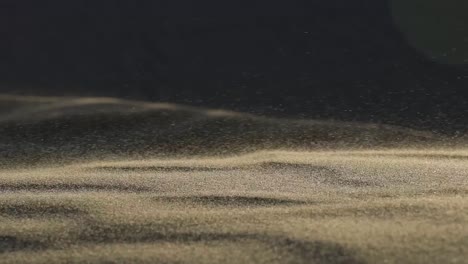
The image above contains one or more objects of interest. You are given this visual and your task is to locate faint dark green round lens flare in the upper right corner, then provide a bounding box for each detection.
[391,0,468,65]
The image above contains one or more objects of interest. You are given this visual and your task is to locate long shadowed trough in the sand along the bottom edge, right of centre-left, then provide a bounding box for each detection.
[80,226,364,264]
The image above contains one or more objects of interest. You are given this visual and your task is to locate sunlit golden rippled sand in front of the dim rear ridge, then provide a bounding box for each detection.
[0,150,468,263]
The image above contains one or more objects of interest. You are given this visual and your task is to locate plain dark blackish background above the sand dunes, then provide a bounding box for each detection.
[0,0,468,134]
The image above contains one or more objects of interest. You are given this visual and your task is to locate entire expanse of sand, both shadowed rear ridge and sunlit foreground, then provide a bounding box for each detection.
[0,96,468,264]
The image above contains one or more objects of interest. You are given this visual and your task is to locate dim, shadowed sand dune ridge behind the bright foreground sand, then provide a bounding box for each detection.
[0,96,453,164]
